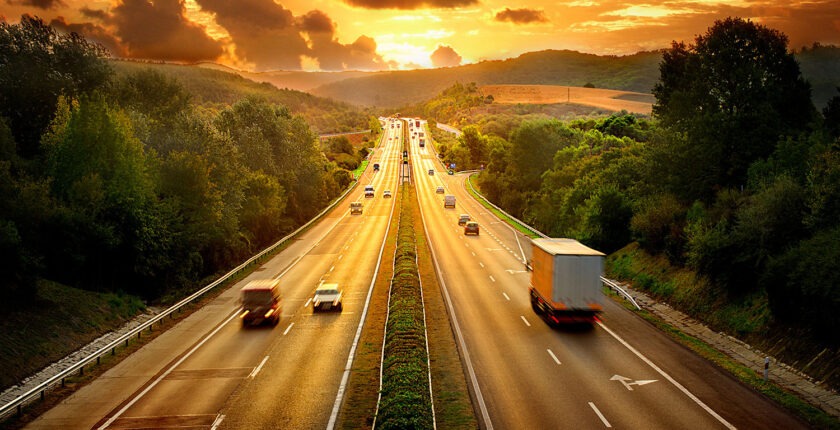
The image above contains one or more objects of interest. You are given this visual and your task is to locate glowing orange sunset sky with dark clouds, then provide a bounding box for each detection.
[0,0,840,71]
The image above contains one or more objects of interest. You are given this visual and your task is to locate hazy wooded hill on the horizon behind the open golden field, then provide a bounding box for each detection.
[312,51,661,108]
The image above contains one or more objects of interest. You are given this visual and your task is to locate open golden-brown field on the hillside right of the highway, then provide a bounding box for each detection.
[479,85,654,115]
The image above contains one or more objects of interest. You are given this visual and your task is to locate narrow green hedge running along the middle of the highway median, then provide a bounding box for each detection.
[376,186,434,429]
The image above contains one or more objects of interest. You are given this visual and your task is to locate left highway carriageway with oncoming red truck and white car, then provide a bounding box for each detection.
[28,118,402,429]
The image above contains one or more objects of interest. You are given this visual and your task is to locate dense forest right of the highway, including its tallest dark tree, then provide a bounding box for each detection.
[436,19,840,348]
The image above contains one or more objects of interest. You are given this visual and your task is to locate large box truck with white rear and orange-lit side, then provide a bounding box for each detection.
[530,239,604,326]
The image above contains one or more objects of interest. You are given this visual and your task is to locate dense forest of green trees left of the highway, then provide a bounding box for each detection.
[0,16,369,308]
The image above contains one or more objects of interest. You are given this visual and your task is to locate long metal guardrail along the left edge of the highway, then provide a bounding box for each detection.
[0,176,359,418]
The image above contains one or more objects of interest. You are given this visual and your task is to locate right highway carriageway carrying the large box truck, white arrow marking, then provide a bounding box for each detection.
[411,119,807,429]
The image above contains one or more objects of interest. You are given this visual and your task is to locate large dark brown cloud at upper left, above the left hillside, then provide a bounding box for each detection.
[108,0,223,62]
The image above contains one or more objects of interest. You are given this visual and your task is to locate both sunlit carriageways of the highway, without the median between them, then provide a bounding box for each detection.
[23,117,806,429]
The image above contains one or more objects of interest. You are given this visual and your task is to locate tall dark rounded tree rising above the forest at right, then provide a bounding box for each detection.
[653,18,816,200]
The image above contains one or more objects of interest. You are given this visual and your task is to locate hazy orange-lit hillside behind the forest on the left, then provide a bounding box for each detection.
[111,60,369,133]
